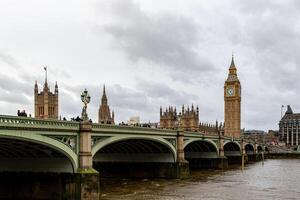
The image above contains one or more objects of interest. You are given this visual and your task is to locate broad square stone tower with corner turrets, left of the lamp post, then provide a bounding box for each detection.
[34,79,58,119]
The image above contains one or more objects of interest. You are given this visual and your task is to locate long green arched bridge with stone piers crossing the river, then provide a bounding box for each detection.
[0,115,264,199]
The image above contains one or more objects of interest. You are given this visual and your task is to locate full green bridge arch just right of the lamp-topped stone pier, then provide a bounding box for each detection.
[92,135,177,162]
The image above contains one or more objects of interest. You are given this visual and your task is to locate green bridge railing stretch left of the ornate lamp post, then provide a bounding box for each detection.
[0,115,79,131]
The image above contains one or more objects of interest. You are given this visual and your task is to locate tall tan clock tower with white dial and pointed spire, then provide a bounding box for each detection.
[224,55,241,137]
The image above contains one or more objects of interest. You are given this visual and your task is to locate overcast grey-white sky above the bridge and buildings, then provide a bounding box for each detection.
[0,0,300,130]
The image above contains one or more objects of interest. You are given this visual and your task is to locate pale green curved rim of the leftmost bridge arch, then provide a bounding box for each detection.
[0,132,78,173]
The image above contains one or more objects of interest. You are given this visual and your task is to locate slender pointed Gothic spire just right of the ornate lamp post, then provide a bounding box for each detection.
[98,85,115,124]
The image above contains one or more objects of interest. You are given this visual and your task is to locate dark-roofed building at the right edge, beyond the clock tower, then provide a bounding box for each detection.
[279,105,300,146]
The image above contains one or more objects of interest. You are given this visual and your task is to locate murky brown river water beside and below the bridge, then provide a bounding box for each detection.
[101,159,300,200]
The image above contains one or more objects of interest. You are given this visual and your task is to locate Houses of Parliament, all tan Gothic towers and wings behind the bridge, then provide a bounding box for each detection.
[34,56,241,137]
